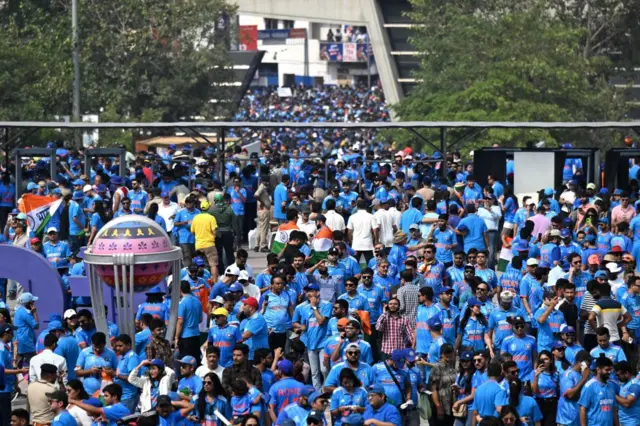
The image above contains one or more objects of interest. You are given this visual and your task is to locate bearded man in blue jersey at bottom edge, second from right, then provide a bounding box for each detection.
[578,356,618,426]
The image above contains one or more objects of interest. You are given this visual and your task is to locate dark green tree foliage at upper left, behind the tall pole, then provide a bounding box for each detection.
[0,0,234,138]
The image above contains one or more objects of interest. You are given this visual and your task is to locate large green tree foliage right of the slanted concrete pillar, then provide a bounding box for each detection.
[396,0,624,152]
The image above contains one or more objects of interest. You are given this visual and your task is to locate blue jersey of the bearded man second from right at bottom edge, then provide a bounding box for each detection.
[578,378,617,426]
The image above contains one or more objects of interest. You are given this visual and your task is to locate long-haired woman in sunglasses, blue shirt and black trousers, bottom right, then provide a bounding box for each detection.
[531,351,560,426]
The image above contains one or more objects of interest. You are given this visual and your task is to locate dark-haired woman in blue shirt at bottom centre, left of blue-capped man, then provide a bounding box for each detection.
[330,368,367,426]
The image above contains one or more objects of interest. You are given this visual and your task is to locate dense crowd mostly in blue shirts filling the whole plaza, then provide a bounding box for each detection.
[0,85,640,426]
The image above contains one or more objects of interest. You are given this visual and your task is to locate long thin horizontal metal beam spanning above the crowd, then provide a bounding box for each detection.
[0,121,640,129]
